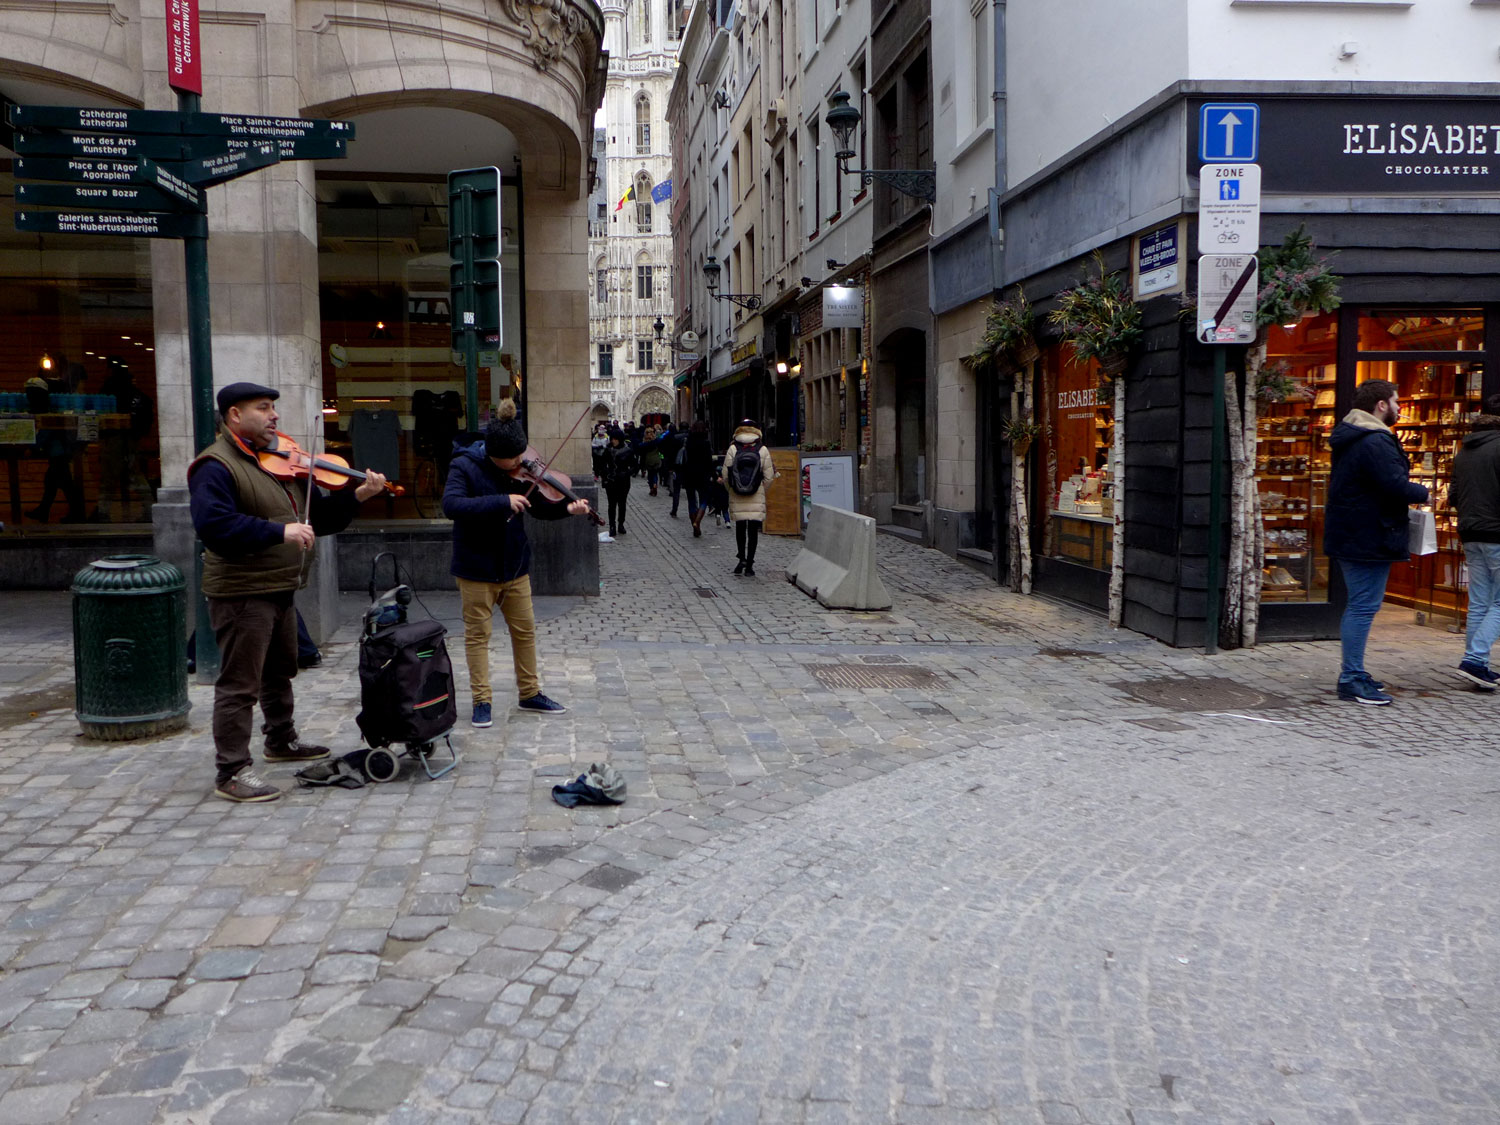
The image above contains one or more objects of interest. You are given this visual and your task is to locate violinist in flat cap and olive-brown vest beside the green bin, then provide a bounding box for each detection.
[188,383,386,801]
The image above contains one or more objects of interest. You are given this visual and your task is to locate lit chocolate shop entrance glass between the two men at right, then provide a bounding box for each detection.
[1355,309,1485,624]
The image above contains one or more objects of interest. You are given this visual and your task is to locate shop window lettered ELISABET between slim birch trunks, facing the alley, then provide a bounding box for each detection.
[1038,345,1115,570]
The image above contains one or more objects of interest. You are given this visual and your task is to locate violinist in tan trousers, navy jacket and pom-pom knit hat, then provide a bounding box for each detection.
[443,399,590,726]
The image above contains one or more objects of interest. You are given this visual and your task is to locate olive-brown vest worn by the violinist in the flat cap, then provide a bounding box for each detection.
[188,431,314,597]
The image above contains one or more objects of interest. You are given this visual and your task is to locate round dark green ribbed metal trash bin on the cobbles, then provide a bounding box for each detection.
[72,555,191,743]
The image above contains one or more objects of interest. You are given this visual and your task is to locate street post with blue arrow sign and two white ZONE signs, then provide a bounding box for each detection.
[1197,102,1260,654]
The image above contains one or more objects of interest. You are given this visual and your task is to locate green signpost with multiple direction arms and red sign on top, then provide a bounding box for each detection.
[8,0,354,683]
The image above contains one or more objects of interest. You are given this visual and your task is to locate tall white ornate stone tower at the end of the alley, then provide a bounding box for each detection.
[588,0,681,419]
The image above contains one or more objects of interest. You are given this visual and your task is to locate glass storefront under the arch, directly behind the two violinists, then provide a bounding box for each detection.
[318,173,525,519]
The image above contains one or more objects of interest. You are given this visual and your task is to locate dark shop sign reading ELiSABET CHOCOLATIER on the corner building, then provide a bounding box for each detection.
[1188,95,1500,195]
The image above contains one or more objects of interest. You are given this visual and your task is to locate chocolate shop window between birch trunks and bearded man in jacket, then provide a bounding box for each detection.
[1256,314,1338,602]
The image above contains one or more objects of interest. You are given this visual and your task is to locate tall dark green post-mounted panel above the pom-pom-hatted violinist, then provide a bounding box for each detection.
[449,168,501,432]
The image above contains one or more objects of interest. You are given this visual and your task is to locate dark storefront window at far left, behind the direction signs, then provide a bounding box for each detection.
[0,161,161,528]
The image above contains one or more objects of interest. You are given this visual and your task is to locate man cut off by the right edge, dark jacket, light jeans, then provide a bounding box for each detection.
[1448,395,1500,692]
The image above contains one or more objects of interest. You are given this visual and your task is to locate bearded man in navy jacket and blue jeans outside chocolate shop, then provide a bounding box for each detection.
[1323,380,1427,707]
